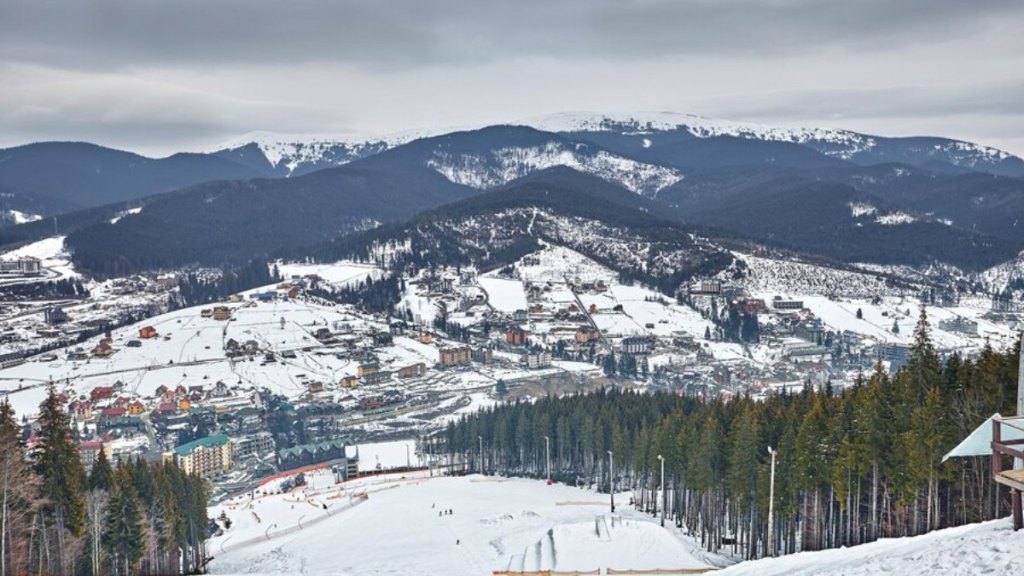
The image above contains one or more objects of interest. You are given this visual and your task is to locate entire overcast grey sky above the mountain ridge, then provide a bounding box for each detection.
[0,0,1024,156]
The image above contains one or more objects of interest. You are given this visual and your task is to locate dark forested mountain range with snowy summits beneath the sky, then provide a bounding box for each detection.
[0,114,1024,274]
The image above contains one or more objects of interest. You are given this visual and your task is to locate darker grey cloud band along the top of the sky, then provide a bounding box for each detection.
[0,0,1024,70]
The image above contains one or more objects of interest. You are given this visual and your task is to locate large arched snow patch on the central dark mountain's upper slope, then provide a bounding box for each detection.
[427,141,683,196]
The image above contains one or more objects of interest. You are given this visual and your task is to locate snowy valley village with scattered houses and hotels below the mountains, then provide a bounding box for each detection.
[0,239,1019,494]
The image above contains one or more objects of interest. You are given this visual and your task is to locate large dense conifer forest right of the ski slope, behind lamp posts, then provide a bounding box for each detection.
[437,313,1019,559]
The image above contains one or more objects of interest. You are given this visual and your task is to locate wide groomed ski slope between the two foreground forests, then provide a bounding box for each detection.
[210,475,707,576]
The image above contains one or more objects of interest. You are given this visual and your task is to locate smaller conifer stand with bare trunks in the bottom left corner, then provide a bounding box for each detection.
[0,388,209,576]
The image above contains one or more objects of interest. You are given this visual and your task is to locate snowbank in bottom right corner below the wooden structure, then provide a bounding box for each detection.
[716,519,1024,576]
